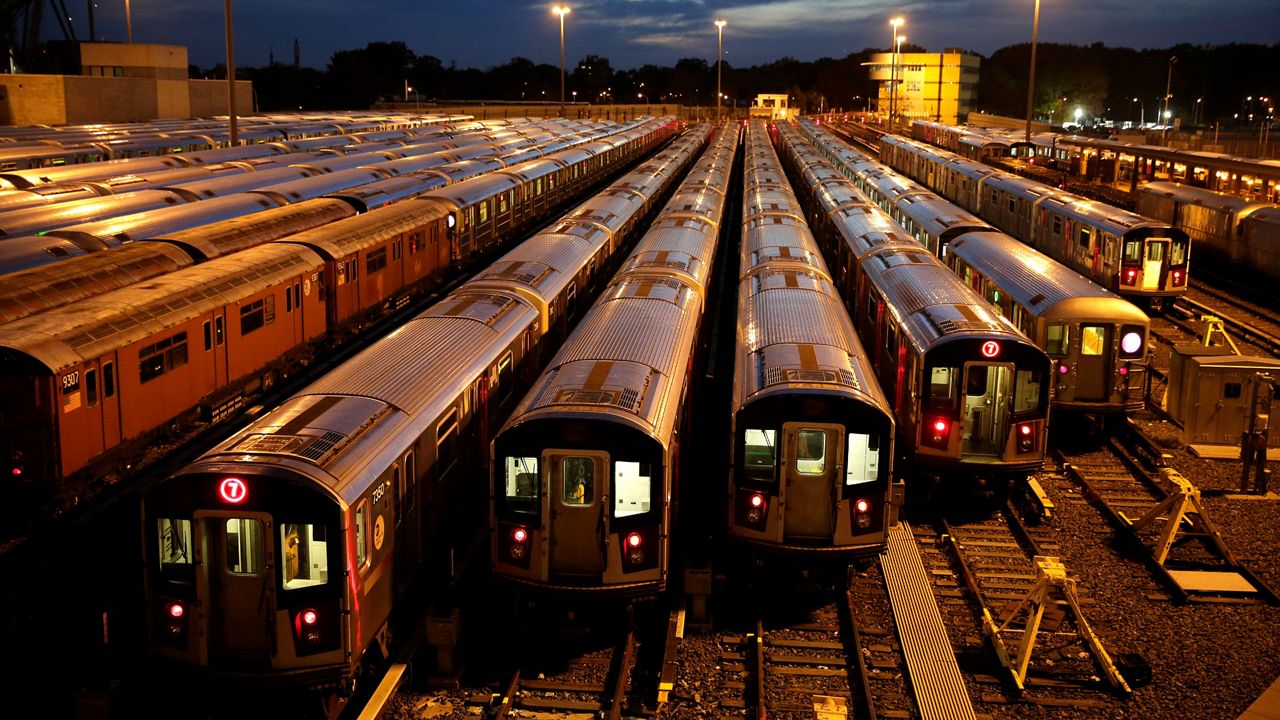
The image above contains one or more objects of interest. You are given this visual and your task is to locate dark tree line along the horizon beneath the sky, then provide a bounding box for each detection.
[204,41,1280,124]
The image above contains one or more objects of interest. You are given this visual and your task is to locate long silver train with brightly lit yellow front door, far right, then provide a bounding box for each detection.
[881,130,1190,310]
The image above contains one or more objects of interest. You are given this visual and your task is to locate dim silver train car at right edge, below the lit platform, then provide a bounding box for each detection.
[1135,182,1280,267]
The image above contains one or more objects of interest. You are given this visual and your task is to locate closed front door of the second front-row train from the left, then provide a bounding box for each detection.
[543,451,609,577]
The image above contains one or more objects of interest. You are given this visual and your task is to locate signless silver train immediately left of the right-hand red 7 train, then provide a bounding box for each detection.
[728,122,902,550]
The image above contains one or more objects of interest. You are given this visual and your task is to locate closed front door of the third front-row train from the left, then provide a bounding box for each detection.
[782,423,845,541]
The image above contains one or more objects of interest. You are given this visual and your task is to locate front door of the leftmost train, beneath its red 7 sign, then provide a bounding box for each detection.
[196,512,275,669]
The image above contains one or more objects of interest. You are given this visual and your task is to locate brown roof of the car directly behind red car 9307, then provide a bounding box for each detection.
[0,237,195,324]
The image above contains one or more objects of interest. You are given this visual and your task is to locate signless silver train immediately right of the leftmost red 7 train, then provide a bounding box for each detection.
[489,123,740,600]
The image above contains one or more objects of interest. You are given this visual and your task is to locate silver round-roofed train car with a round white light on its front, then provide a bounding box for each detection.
[947,232,1149,413]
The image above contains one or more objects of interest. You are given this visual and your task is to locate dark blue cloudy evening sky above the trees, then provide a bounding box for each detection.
[77,0,1280,69]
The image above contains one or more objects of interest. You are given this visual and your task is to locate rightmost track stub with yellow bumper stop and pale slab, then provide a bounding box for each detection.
[1053,424,1277,603]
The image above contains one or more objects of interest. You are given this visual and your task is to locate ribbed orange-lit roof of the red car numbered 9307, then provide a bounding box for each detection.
[0,245,324,373]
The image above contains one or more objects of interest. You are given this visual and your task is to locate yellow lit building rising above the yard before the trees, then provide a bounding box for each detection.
[867,47,982,124]
